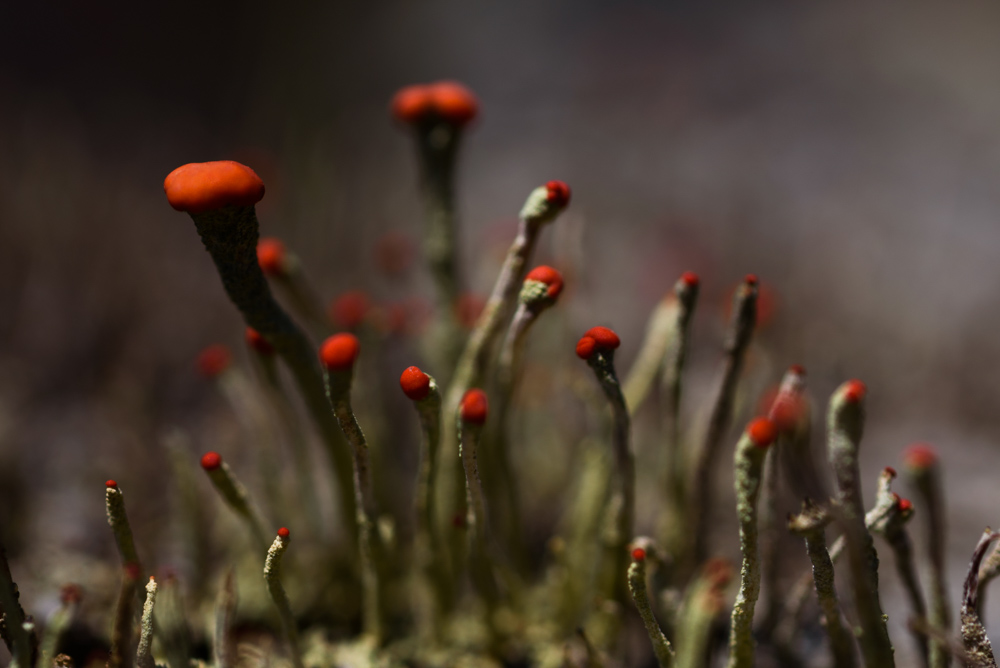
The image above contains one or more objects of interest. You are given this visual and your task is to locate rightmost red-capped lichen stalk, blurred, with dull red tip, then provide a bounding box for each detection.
[903,443,951,668]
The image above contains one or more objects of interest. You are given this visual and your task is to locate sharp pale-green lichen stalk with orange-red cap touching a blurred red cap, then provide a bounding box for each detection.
[727,418,777,668]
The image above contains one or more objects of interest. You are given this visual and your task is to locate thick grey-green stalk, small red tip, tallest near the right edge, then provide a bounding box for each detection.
[827,380,895,668]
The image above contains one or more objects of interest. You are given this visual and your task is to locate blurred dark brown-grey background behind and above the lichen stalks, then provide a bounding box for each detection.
[0,1,1000,664]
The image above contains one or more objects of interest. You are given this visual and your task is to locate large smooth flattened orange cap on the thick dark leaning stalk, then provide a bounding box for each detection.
[163,160,264,213]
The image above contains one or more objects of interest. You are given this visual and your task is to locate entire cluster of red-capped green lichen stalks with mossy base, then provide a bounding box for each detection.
[0,82,1000,668]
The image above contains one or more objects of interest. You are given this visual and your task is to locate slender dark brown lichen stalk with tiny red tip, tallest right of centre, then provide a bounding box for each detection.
[688,274,757,564]
